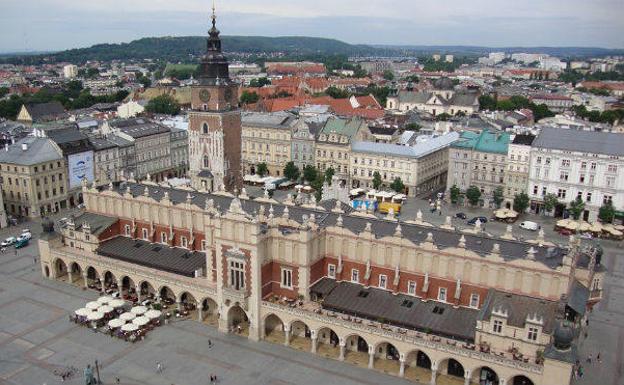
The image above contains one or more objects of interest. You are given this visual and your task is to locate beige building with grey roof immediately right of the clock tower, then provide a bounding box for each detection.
[241,112,298,176]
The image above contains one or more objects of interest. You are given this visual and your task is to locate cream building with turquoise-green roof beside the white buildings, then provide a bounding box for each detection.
[446,129,509,206]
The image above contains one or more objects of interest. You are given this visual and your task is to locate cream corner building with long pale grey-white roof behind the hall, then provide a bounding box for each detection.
[351,132,459,196]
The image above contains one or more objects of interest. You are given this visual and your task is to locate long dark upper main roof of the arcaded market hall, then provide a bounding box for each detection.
[106,183,564,269]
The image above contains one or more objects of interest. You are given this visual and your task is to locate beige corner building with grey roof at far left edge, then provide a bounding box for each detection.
[0,137,68,218]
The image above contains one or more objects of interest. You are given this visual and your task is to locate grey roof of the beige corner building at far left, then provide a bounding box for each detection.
[0,136,63,166]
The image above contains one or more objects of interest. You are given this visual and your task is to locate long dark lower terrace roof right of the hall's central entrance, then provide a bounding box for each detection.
[311,278,479,342]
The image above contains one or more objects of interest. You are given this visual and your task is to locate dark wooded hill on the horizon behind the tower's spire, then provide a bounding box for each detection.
[1,36,377,63]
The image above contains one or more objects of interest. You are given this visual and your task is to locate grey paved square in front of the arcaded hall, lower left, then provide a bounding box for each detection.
[0,238,420,385]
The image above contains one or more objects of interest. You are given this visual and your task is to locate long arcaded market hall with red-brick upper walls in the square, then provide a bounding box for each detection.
[39,182,604,385]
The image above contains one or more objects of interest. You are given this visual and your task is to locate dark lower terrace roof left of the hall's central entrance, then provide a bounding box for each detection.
[96,236,206,277]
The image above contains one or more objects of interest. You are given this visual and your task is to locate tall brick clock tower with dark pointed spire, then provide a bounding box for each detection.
[189,6,242,191]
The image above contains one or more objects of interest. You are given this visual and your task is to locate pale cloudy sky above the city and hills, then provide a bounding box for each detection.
[0,0,624,52]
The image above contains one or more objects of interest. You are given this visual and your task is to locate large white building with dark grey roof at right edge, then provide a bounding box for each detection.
[527,127,624,221]
